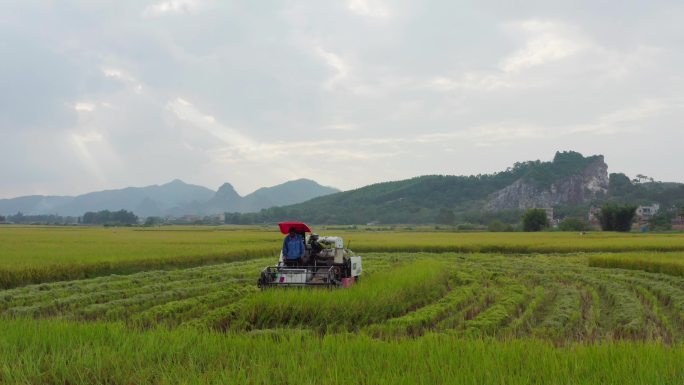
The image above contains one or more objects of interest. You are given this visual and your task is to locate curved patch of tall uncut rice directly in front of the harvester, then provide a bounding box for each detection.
[235,259,451,330]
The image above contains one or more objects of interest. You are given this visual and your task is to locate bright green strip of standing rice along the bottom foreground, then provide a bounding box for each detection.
[0,320,684,385]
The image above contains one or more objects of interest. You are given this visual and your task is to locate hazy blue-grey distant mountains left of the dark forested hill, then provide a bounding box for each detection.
[0,179,339,217]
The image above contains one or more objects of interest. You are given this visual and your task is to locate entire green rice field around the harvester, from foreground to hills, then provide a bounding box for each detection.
[0,228,684,384]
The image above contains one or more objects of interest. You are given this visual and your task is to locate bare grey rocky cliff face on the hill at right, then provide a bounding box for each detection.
[484,156,609,211]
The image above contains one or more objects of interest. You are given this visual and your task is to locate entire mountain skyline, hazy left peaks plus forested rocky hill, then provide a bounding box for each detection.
[5,151,684,224]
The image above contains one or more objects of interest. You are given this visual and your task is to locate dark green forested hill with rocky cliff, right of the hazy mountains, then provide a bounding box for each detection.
[227,151,684,224]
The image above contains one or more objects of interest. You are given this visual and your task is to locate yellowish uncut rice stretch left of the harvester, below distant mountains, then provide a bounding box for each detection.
[0,226,280,289]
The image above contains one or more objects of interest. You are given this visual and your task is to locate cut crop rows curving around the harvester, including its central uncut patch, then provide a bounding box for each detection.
[0,254,684,344]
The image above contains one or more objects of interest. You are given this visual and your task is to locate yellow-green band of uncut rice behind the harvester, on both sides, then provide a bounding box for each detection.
[0,226,684,288]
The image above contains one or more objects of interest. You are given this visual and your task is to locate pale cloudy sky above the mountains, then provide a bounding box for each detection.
[0,0,684,198]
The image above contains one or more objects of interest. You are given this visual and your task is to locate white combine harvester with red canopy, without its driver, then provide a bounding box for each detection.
[257,222,361,289]
